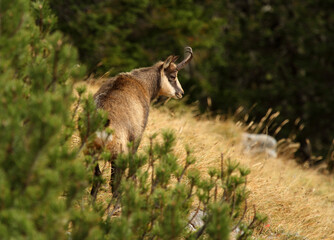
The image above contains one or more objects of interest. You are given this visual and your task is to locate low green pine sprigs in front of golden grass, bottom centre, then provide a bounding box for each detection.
[85,131,266,240]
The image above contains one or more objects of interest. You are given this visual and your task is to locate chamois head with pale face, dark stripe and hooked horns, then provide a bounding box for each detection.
[159,47,193,99]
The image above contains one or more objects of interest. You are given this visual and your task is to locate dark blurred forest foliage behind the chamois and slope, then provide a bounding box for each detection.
[50,0,334,161]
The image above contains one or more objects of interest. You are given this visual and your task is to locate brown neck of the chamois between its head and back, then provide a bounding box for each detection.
[129,62,163,101]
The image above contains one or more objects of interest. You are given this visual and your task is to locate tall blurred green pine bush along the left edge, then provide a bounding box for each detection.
[0,0,87,239]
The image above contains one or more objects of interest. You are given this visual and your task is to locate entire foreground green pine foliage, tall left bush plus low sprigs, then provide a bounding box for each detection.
[0,0,265,240]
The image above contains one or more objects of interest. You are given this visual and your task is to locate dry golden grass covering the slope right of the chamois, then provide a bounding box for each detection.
[75,82,334,240]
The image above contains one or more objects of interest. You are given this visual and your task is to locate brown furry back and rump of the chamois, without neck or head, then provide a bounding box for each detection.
[94,74,150,154]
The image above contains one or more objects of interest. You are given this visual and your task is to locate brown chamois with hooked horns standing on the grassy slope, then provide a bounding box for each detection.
[91,47,193,196]
